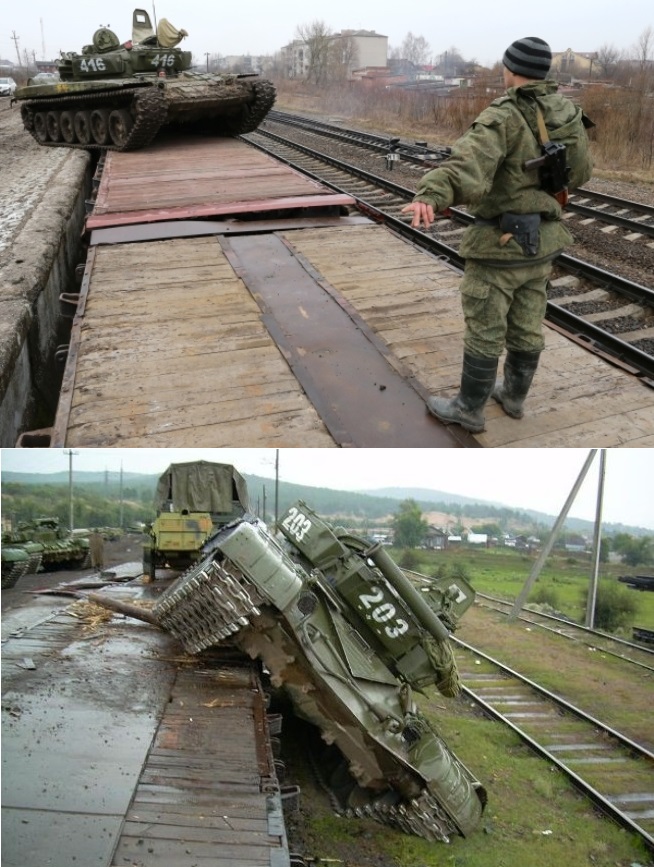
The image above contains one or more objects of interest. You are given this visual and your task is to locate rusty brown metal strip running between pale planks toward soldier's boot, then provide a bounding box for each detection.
[222,235,475,448]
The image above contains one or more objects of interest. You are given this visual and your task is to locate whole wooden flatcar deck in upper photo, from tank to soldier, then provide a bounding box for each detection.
[19,135,654,448]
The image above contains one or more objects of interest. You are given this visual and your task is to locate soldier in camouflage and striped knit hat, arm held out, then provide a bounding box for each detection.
[404,36,592,433]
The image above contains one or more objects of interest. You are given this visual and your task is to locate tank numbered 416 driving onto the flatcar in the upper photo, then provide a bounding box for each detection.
[14,9,275,151]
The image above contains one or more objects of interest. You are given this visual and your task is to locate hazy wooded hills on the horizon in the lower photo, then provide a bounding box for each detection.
[2,474,654,566]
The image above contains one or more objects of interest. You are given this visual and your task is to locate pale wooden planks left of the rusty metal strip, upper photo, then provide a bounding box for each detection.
[60,238,334,447]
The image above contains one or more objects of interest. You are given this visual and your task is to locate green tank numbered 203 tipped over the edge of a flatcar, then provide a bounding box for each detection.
[153,501,486,841]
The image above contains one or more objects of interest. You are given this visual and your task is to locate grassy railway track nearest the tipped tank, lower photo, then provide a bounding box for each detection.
[451,636,654,851]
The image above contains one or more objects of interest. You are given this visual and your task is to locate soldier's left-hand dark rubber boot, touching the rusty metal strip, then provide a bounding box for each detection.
[427,352,498,433]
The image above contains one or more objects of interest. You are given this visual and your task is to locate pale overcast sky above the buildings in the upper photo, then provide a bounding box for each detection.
[0,0,654,65]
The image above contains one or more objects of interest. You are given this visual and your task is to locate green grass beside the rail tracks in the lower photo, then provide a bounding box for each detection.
[288,549,654,867]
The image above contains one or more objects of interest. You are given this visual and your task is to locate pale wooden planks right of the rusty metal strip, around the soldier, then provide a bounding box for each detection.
[286,220,654,448]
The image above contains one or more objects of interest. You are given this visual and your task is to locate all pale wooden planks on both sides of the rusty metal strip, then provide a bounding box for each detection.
[57,216,654,448]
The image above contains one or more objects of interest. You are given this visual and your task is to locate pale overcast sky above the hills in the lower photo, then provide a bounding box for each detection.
[0,449,654,530]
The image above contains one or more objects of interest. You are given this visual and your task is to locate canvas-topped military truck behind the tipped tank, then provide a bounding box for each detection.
[143,461,249,581]
